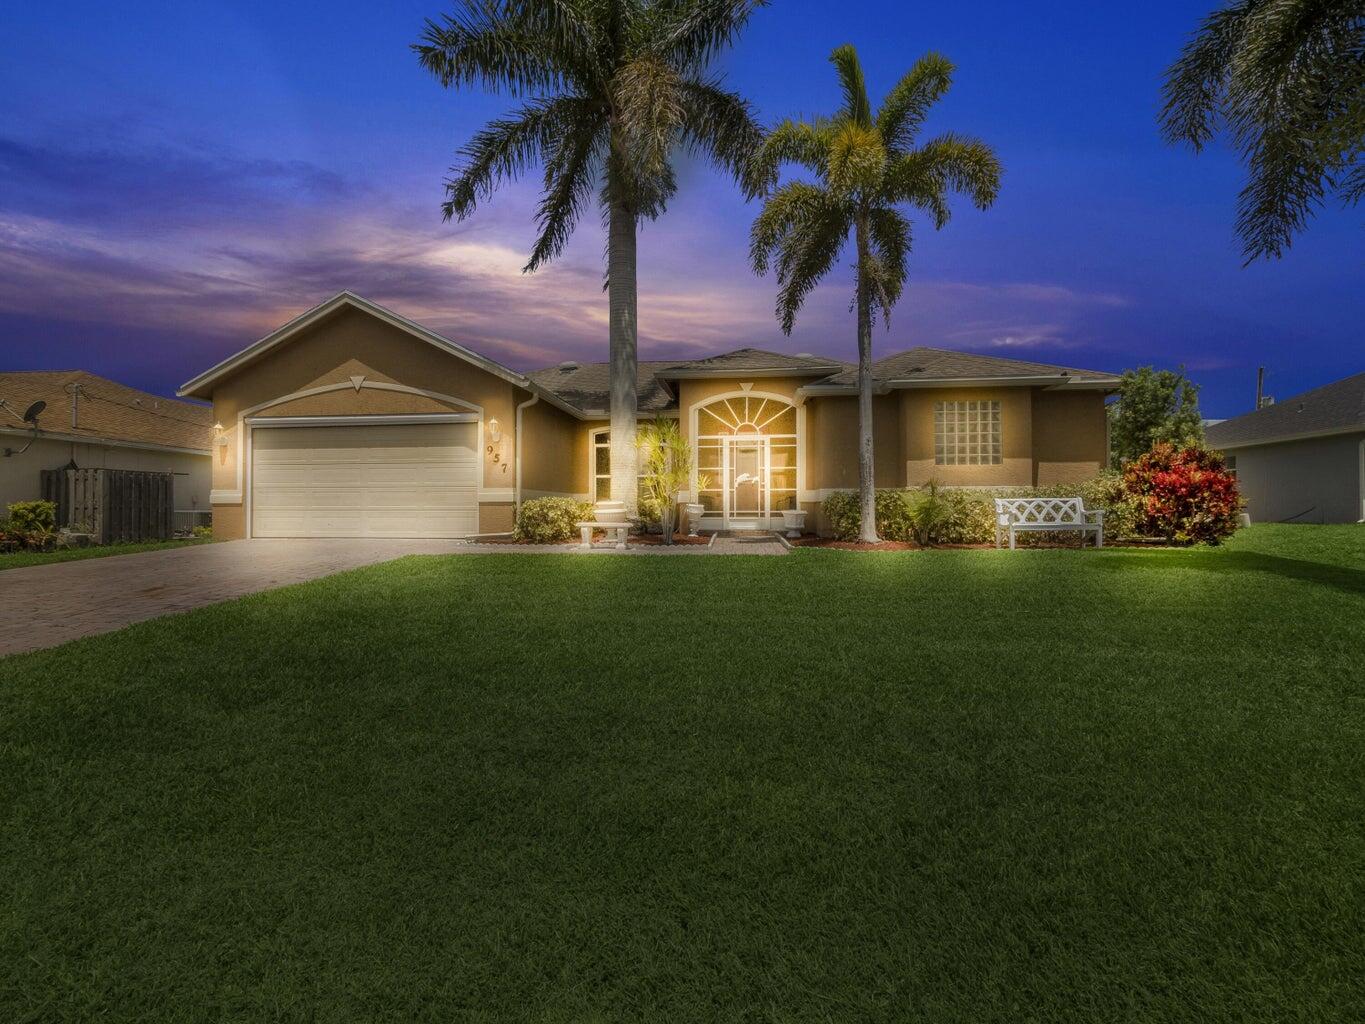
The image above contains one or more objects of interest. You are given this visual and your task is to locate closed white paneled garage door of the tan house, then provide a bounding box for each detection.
[251,423,479,537]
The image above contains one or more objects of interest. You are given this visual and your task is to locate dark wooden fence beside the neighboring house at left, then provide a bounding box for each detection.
[42,470,175,543]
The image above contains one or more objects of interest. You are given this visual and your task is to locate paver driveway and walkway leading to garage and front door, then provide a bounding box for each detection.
[0,537,786,655]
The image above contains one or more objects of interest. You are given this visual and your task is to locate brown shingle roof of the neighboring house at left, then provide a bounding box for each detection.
[0,370,213,452]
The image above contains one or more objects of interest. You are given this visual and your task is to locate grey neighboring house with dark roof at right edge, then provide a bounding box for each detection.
[1207,373,1365,523]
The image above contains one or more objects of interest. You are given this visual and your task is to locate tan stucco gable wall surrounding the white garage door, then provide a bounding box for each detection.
[204,309,531,539]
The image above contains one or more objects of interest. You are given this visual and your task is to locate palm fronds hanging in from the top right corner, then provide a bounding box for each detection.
[1162,0,1365,264]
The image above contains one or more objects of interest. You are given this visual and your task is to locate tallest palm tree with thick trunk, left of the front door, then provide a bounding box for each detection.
[414,0,767,509]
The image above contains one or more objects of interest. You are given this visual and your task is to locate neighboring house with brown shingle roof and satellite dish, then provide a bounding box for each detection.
[0,370,213,526]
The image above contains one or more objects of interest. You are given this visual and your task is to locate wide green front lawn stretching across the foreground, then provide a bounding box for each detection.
[0,526,1365,1024]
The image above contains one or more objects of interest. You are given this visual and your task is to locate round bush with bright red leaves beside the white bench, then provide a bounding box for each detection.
[1123,442,1242,543]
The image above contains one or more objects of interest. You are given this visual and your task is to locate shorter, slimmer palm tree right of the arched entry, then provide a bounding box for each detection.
[749,46,1001,543]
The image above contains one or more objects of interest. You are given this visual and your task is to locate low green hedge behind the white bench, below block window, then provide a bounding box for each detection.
[824,472,1138,543]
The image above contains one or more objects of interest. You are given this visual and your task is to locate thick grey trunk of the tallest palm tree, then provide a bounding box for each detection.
[606,193,640,516]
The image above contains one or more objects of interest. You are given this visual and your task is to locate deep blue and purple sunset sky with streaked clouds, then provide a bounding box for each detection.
[0,0,1365,416]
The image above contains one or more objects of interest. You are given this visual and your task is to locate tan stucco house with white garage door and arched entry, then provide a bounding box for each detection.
[180,292,1118,538]
